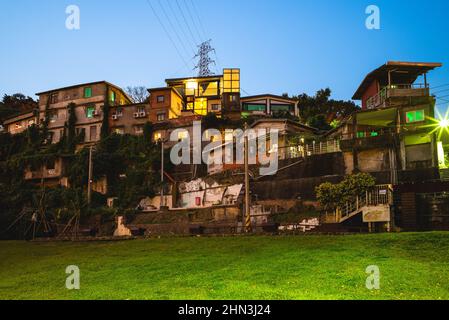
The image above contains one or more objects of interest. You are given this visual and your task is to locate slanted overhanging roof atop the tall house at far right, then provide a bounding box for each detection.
[352,61,442,100]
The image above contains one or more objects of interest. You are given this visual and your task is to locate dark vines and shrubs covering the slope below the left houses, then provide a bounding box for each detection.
[0,104,164,238]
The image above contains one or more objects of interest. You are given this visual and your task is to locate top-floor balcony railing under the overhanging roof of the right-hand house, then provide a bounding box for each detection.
[366,84,429,109]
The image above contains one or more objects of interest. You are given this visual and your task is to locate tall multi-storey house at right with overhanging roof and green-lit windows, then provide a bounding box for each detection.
[329,61,441,184]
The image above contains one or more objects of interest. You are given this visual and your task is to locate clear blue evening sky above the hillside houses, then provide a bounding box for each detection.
[0,0,449,109]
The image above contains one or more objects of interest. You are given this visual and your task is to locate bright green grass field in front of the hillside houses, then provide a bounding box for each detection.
[0,232,449,299]
